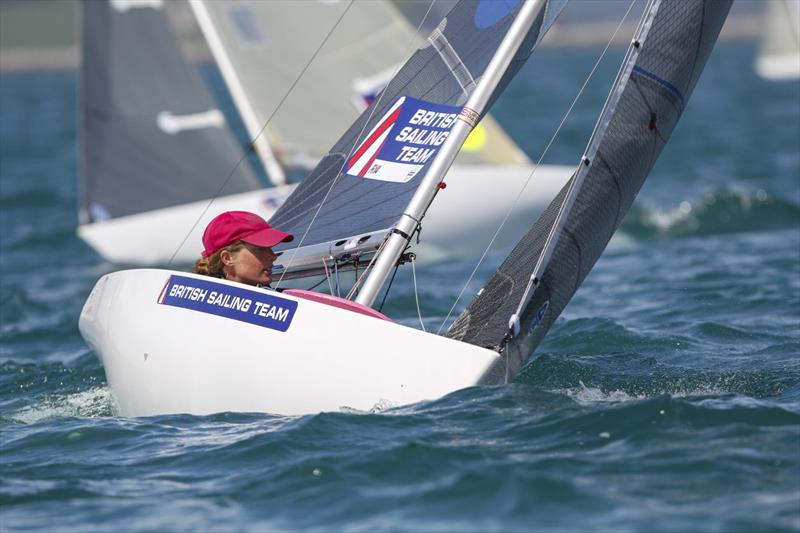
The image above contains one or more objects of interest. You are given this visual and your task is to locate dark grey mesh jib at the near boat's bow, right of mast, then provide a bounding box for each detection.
[447,0,732,383]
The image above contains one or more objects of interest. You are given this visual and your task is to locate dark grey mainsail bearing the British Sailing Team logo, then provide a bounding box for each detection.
[271,0,565,260]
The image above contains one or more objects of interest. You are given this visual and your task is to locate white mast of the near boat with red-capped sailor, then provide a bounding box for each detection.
[354,0,546,306]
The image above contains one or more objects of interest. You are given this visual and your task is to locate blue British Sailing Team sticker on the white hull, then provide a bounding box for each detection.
[158,276,297,331]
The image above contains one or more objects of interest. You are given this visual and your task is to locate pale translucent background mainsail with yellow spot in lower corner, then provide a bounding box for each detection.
[194,0,528,166]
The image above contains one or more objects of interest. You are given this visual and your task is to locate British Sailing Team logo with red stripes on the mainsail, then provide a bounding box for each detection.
[345,96,461,183]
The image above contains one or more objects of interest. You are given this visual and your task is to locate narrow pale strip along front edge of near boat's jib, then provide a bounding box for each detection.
[509,0,661,335]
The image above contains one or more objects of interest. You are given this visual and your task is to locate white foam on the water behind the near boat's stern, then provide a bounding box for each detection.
[10,387,116,424]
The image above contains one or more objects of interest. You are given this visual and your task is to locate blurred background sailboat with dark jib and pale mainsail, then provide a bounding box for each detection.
[78,0,572,265]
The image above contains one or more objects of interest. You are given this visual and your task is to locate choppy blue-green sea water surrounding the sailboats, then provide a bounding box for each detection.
[0,39,800,531]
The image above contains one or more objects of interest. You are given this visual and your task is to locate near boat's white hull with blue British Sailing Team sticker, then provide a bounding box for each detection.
[80,269,499,416]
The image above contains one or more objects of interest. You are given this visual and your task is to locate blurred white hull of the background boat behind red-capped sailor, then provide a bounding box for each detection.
[78,161,574,266]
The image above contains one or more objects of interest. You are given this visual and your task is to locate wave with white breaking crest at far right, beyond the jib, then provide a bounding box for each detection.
[621,189,800,240]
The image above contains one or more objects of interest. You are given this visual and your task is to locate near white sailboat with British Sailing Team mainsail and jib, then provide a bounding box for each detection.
[80,0,732,416]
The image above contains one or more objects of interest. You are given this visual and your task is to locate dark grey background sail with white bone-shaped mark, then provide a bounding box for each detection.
[80,0,259,223]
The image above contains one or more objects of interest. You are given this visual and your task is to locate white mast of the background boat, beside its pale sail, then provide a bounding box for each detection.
[189,0,287,185]
